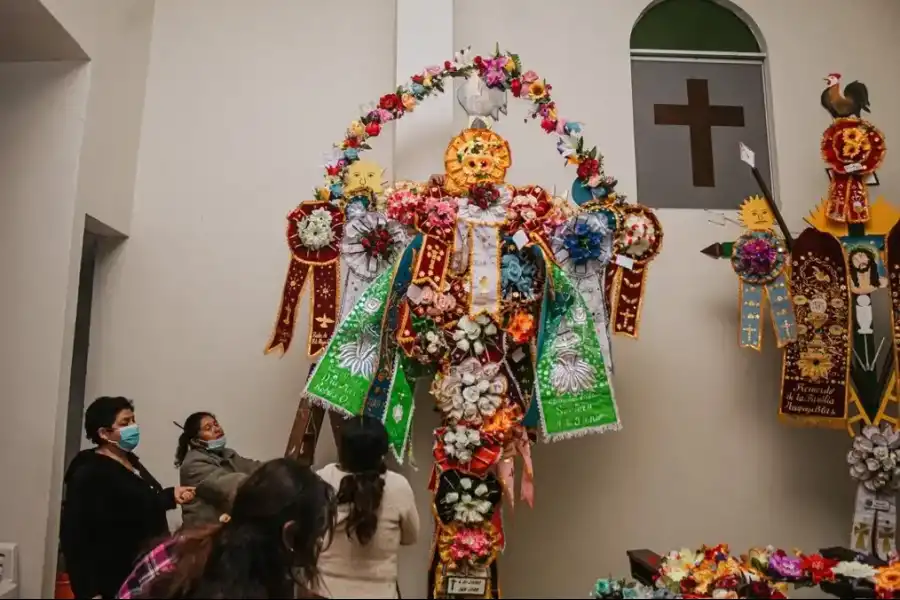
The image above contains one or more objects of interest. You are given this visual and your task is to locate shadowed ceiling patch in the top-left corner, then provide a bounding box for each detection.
[0,0,89,62]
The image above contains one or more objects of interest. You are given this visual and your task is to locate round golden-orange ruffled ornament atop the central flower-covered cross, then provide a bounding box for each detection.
[444,129,512,194]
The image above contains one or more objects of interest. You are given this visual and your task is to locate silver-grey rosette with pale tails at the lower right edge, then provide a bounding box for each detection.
[847,422,900,560]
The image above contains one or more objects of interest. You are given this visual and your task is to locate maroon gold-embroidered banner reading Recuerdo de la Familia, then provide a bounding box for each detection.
[778,228,851,427]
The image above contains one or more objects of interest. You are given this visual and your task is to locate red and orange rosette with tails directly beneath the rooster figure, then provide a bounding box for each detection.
[822,117,887,223]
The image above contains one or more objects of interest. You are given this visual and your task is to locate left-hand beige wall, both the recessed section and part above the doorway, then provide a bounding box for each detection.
[0,0,153,597]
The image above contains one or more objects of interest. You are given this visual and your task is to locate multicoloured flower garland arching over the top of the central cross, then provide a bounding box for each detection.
[315,48,625,206]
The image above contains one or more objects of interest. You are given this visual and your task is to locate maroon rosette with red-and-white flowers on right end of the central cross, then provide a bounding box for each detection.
[606,204,663,338]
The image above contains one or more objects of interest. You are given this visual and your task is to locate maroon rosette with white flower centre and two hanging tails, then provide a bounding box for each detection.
[266,202,344,356]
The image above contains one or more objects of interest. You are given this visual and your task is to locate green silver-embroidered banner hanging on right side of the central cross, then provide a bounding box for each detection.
[536,262,621,441]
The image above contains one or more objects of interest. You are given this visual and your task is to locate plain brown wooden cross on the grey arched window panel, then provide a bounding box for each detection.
[653,79,744,187]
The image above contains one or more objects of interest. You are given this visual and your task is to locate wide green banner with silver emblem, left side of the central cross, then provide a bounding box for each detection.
[306,270,394,416]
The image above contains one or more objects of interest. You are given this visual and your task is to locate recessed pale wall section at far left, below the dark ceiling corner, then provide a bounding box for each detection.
[0,63,89,597]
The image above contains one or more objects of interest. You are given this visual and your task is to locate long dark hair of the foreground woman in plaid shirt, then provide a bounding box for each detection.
[142,458,335,598]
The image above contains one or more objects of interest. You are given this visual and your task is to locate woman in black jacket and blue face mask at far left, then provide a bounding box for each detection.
[60,396,194,598]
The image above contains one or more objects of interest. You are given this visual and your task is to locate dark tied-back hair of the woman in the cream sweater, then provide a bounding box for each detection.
[337,416,388,545]
